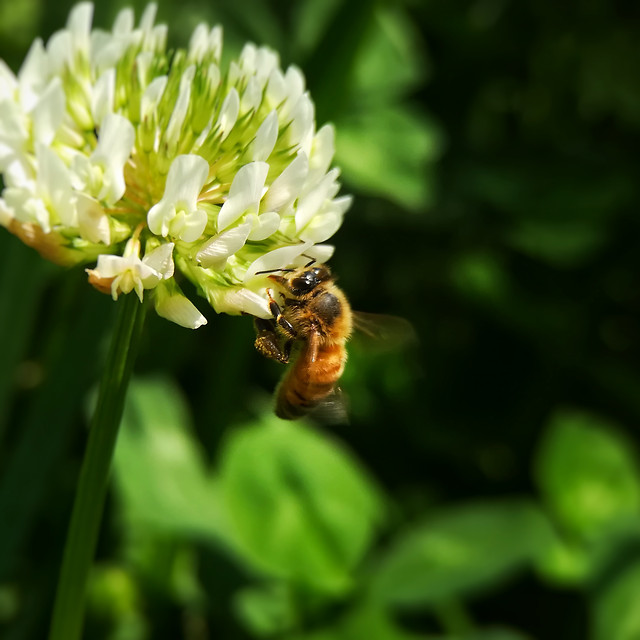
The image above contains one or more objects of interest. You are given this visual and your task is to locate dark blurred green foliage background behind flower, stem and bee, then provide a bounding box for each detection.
[0,0,640,640]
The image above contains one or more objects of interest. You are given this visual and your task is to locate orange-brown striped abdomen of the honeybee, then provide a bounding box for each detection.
[276,344,347,420]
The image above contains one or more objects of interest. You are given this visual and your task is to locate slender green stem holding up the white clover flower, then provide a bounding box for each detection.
[49,293,145,640]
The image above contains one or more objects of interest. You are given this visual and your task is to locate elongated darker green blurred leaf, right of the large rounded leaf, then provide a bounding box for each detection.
[372,500,549,606]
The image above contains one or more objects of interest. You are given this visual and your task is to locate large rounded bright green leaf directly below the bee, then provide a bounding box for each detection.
[221,415,381,591]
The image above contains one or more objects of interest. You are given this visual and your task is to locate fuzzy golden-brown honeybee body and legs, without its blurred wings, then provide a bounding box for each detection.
[255,263,353,420]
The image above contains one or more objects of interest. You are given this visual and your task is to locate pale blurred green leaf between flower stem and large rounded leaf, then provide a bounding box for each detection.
[114,378,227,541]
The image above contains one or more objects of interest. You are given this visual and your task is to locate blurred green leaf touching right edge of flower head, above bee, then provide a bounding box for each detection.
[336,105,441,209]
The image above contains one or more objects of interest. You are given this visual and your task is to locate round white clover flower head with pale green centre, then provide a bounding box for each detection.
[0,3,351,328]
